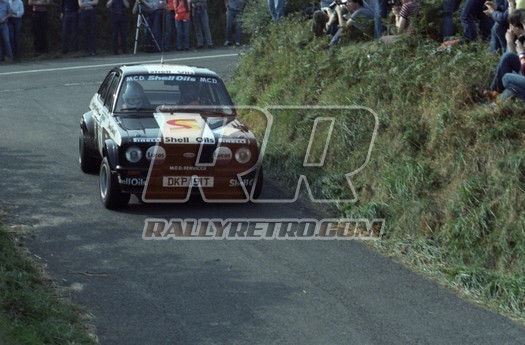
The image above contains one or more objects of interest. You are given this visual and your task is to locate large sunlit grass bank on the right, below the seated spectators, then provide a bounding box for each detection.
[230,18,525,319]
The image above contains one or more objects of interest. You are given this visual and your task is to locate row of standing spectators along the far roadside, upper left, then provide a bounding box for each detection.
[0,0,248,63]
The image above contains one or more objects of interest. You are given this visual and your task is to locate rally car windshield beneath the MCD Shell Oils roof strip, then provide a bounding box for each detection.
[115,74,233,113]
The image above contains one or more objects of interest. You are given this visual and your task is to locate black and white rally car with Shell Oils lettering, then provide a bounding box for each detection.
[79,64,263,209]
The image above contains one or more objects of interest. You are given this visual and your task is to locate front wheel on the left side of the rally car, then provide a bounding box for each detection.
[99,157,131,210]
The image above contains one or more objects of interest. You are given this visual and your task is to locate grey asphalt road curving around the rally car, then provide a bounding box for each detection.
[0,49,525,345]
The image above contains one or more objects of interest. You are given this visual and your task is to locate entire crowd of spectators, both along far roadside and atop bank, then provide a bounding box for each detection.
[0,0,525,102]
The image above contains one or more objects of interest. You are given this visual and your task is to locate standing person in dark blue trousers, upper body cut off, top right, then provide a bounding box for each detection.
[461,0,494,42]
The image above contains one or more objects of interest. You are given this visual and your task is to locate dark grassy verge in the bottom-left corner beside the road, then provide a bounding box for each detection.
[0,225,95,345]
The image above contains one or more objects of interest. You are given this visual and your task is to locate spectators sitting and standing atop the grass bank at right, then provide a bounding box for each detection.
[310,0,525,102]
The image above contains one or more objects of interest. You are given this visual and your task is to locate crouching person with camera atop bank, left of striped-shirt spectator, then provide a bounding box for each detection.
[330,0,374,45]
